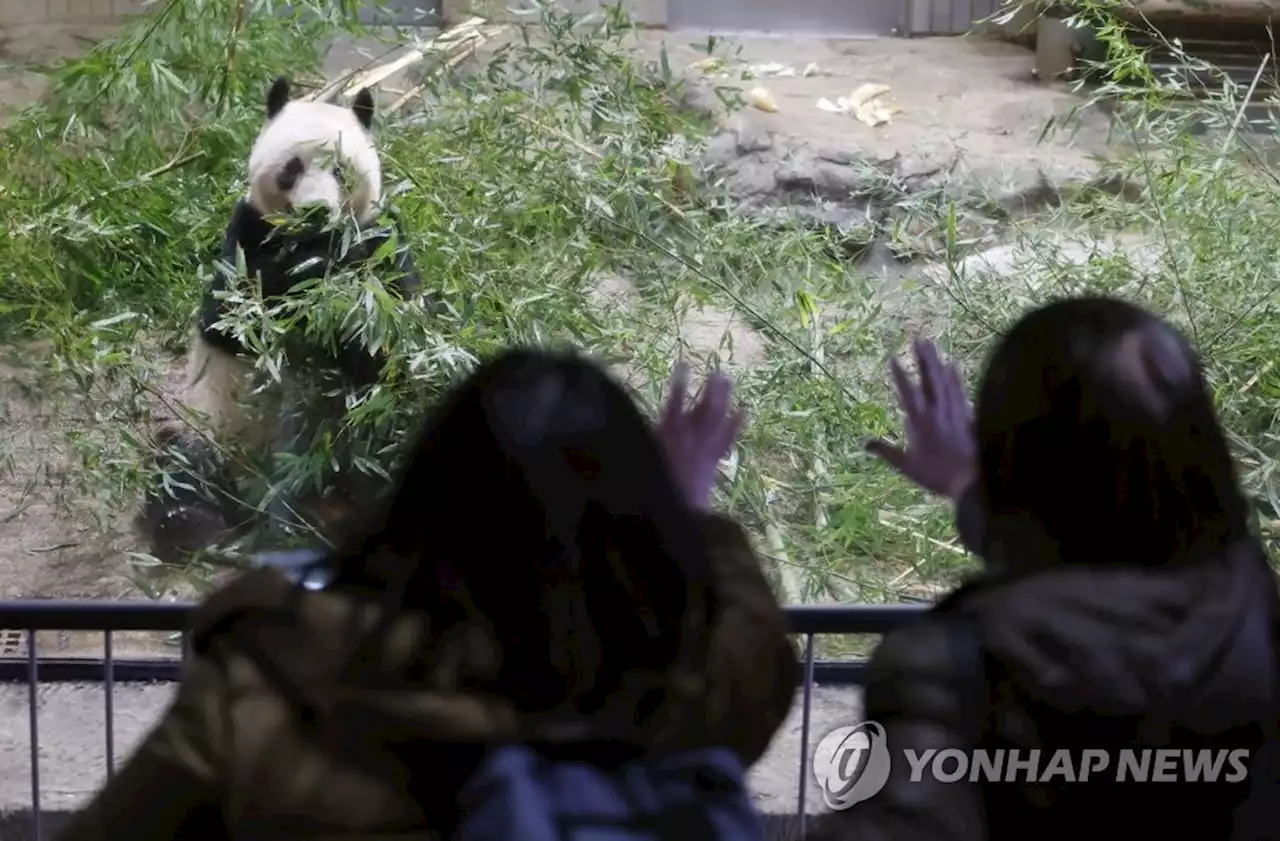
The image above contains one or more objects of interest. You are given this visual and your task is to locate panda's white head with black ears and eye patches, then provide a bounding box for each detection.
[248,77,383,223]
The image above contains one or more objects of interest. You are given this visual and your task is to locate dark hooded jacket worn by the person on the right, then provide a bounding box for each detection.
[810,491,1277,841]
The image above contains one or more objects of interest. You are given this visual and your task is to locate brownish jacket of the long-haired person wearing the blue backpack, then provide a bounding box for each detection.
[58,516,800,841]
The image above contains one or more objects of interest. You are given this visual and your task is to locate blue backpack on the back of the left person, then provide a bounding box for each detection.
[452,744,765,841]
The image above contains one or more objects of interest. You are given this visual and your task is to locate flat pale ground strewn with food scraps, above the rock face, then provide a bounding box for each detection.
[643,32,1110,188]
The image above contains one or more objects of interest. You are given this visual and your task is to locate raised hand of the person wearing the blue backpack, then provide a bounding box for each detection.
[654,362,742,511]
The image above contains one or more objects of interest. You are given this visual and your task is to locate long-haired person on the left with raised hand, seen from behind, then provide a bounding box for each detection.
[59,351,799,841]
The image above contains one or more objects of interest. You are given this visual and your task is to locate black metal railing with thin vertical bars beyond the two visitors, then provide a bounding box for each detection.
[0,600,927,841]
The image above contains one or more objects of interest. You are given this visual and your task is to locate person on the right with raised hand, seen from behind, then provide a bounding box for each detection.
[812,298,1277,841]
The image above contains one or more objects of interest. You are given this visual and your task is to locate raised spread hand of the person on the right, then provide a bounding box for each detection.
[867,337,978,502]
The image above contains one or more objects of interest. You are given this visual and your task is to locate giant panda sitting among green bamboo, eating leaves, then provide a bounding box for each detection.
[140,77,421,558]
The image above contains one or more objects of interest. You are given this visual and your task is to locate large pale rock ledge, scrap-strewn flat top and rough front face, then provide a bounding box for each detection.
[650,35,1152,264]
